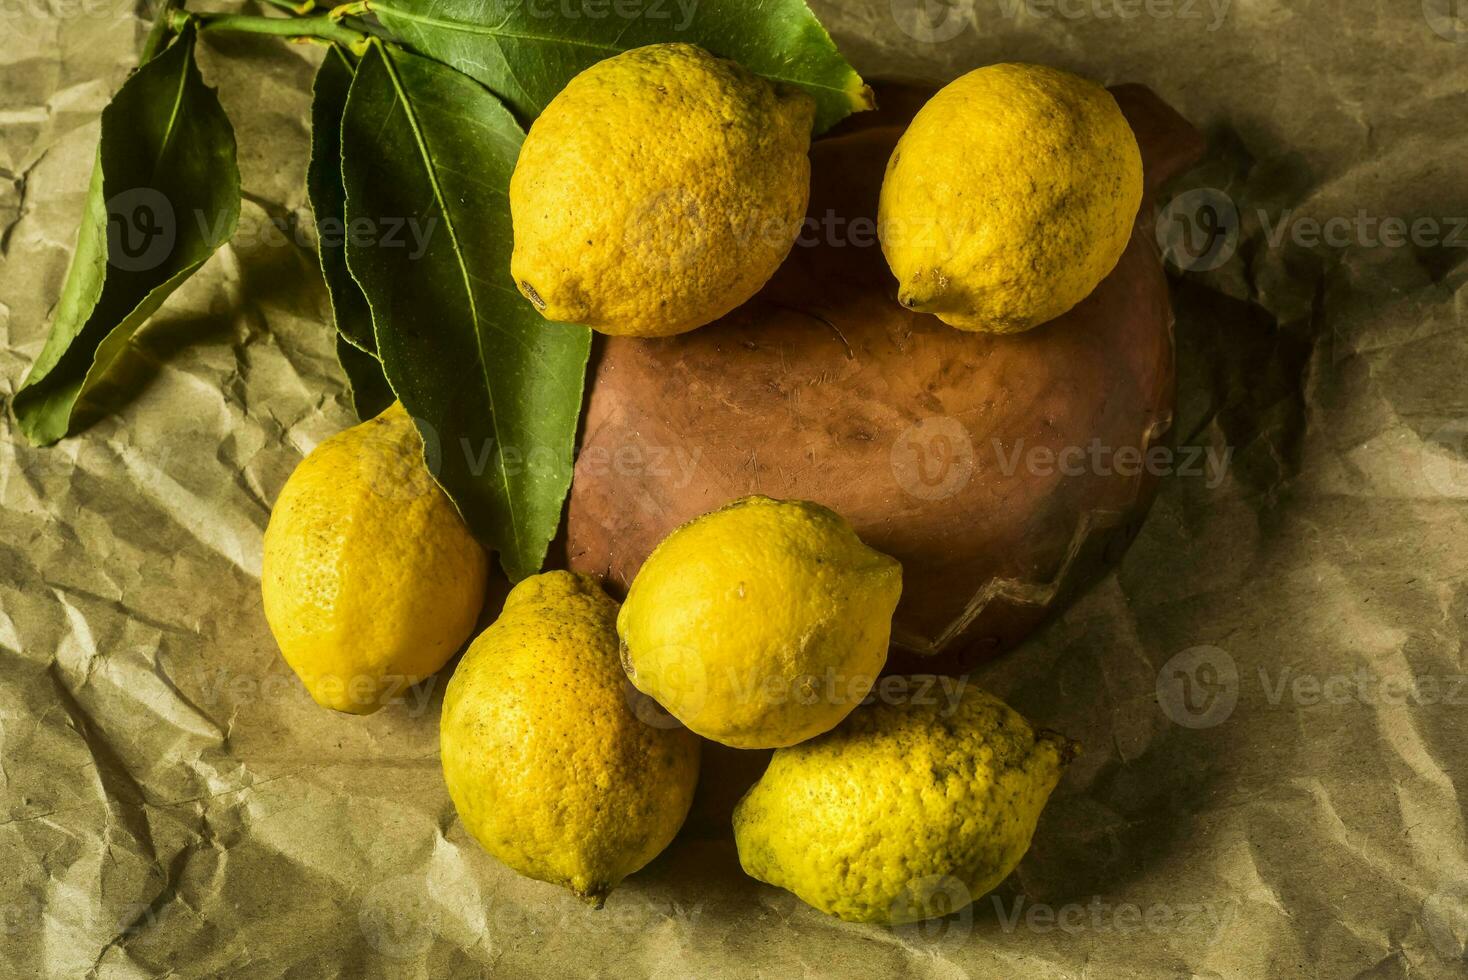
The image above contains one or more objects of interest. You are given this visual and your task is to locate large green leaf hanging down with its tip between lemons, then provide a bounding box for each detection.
[342,43,590,579]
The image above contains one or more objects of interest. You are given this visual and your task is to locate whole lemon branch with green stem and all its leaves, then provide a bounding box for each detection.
[12,0,871,579]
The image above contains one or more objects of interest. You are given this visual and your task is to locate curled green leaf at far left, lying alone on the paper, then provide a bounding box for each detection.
[12,26,239,445]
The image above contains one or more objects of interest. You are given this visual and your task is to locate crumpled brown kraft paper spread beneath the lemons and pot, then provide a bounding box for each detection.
[0,0,1468,977]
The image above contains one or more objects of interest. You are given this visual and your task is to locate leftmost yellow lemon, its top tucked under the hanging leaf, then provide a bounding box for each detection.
[260,402,489,714]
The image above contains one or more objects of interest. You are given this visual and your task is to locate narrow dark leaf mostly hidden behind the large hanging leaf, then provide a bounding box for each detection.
[305,44,393,420]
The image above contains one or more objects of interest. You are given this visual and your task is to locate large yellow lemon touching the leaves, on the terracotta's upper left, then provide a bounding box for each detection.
[509,44,815,337]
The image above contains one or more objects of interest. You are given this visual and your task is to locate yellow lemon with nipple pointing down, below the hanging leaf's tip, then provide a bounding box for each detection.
[439,572,699,905]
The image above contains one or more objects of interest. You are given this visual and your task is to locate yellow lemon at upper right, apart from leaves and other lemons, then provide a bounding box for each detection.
[878,65,1142,333]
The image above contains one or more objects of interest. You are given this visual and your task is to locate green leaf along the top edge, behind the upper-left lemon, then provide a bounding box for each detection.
[371,0,873,132]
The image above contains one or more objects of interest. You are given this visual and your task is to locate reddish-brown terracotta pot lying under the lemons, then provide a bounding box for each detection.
[565,85,1201,670]
